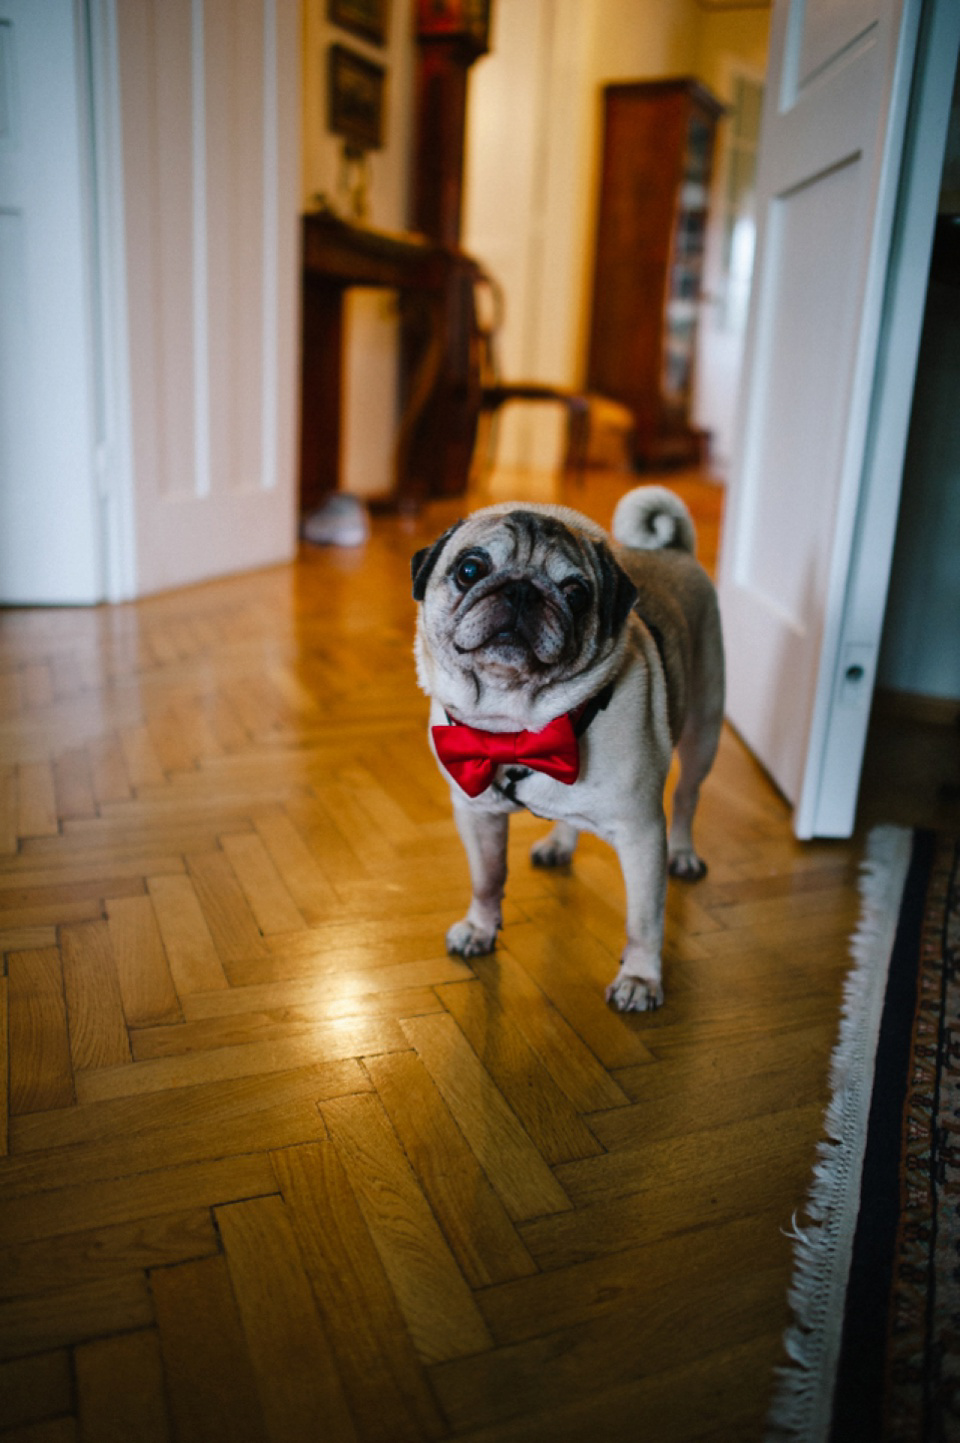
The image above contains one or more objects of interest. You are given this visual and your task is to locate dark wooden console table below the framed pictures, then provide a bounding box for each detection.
[300,212,475,511]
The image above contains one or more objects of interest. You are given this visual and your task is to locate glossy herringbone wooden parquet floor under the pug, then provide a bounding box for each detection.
[0,478,859,1443]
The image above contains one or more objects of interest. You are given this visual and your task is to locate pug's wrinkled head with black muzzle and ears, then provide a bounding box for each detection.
[413,509,637,694]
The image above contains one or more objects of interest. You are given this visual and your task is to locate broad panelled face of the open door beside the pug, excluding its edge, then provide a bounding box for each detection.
[720,0,920,835]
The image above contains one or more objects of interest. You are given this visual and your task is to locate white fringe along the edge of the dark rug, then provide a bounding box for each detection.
[765,827,912,1443]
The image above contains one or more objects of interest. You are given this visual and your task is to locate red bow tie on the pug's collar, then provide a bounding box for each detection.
[430,714,580,797]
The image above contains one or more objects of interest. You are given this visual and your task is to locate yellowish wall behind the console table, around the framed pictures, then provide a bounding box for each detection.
[300,0,414,495]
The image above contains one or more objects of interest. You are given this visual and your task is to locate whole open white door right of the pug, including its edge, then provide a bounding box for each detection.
[720,0,960,837]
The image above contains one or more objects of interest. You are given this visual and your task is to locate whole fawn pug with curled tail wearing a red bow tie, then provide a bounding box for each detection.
[413,486,723,1012]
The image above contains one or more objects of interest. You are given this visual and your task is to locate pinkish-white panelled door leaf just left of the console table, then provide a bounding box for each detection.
[114,0,299,595]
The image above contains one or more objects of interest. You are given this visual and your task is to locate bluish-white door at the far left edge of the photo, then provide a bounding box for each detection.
[0,0,102,603]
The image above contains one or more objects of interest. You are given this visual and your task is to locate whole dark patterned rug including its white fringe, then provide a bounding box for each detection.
[767,827,960,1443]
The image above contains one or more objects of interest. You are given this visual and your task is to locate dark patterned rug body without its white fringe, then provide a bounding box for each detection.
[848,834,960,1443]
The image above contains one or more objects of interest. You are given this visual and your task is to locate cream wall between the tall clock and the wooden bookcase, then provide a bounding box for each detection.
[463,0,592,466]
